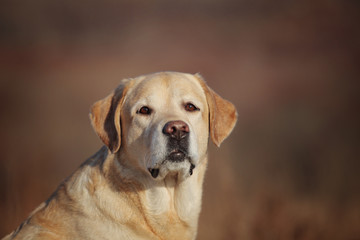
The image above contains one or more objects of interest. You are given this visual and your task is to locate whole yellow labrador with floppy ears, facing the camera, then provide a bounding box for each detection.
[4,72,237,240]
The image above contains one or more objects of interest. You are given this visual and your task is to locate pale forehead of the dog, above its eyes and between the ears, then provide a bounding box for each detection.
[126,73,206,105]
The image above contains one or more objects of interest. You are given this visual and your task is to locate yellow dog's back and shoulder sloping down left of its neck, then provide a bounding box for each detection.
[3,148,107,240]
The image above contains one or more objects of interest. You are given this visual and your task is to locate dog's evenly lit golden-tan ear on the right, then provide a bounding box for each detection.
[195,74,237,147]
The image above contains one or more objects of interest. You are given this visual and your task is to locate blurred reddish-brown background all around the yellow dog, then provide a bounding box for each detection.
[0,0,360,240]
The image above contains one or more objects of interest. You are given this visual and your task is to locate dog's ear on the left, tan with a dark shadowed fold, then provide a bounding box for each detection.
[90,80,128,153]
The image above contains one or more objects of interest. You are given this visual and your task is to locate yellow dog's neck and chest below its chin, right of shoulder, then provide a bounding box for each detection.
[103,148,207,239]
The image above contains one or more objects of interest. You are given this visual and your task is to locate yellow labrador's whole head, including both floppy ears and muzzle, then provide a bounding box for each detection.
[90,72,237,179]
